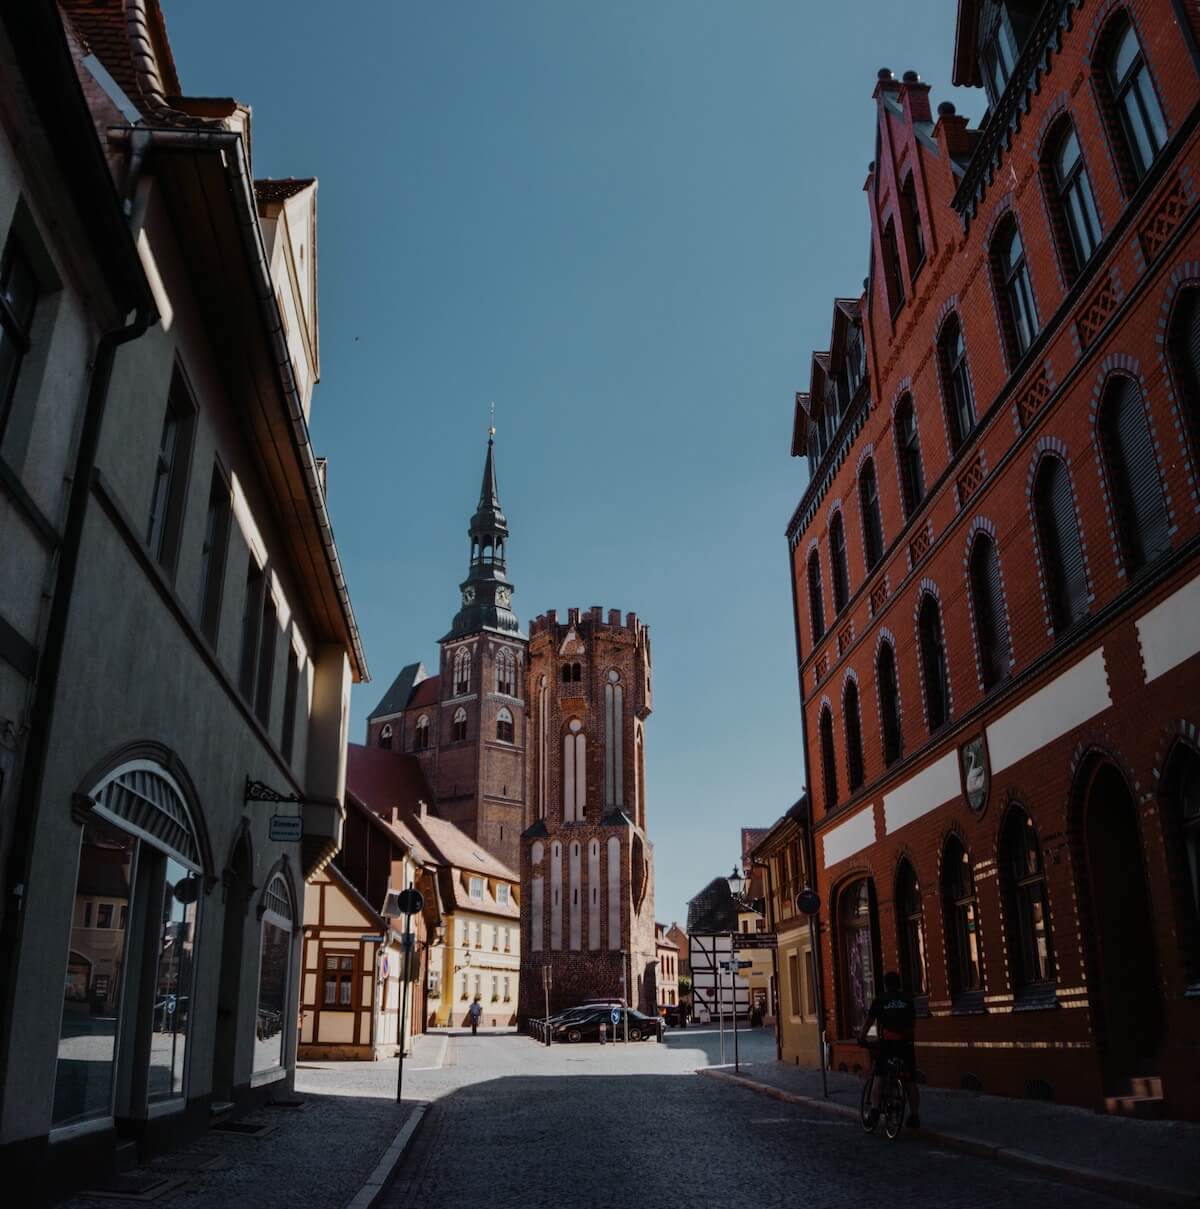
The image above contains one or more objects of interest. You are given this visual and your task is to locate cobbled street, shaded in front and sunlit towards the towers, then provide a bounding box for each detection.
[357,1029,1124,1209]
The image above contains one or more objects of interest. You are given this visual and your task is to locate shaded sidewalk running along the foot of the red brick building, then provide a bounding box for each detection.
[697,1062,1200,1205]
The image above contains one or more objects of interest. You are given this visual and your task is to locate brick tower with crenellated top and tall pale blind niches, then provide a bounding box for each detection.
[518,608,656,1019]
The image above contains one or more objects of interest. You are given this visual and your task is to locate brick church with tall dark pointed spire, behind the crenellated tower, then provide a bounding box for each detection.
[367,432,529,869]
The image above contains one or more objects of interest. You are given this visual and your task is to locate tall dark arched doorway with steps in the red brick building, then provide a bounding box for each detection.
[1083,760,1164,1092]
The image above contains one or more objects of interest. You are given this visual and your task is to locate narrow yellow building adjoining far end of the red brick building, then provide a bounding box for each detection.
[748,797,821,1066]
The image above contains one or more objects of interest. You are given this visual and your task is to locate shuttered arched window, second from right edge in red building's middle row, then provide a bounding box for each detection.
[1097,374,1171,574]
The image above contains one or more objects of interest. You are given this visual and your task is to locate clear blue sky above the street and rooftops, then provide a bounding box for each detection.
[163,0,982,922]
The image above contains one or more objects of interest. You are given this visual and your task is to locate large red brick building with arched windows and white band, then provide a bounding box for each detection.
[788,0,1200,1117]
